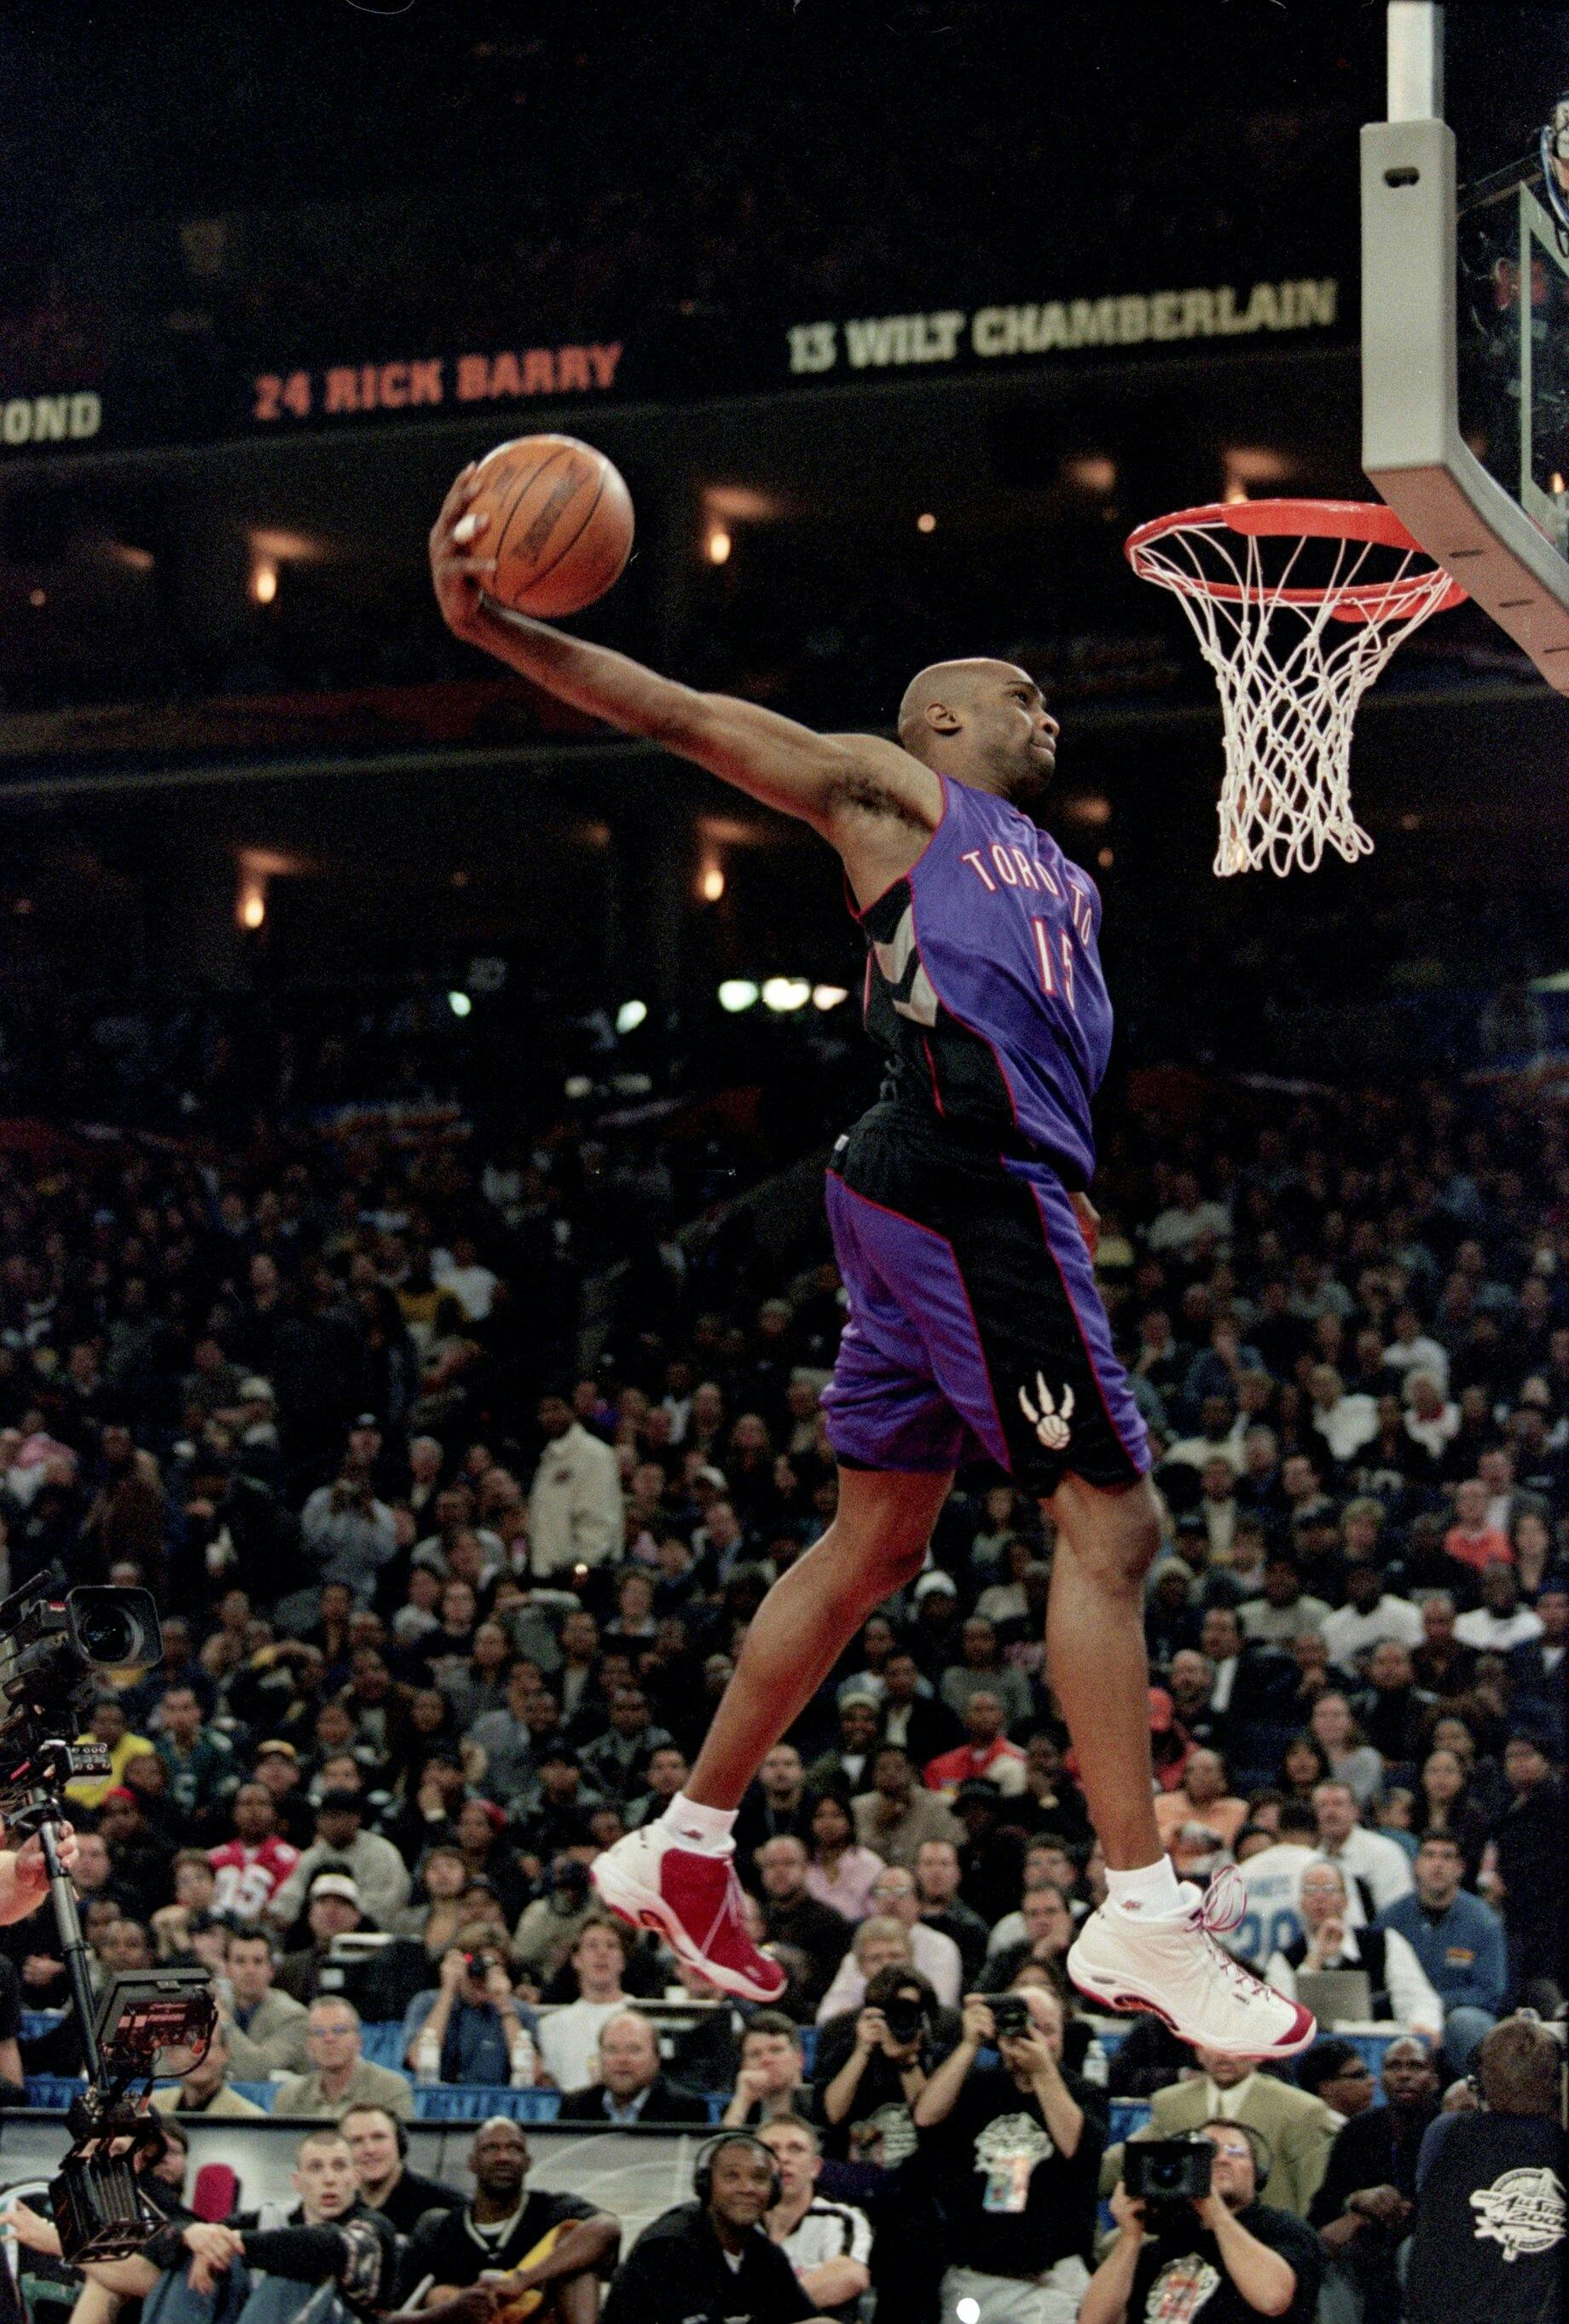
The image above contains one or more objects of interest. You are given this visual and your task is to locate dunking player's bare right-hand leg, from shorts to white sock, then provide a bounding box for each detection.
[1046,1476,1162,1870]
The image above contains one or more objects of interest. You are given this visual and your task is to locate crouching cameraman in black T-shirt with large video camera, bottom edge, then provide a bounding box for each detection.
[1079,2119,1323,2324]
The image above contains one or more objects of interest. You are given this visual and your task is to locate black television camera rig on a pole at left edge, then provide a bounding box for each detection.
[0,1566,217,2261]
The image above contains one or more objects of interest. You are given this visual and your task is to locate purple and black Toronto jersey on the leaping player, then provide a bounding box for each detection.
[855,776,1111,1188]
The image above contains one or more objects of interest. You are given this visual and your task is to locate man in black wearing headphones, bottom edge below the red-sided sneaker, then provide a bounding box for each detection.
[599,2131,841,2324]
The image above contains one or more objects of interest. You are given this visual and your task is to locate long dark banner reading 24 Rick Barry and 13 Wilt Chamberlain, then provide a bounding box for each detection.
[0,272,1355,462]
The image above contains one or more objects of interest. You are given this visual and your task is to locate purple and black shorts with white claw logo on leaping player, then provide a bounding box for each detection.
[823,1107,1150,1497]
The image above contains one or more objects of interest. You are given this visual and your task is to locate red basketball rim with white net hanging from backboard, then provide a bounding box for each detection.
[1127,500,1464,878]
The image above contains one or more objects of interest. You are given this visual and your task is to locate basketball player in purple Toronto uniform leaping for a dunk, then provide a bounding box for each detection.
[430,470,1313,2057]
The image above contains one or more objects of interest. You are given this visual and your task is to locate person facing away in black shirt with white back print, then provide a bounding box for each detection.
[1406,2017,1569,2324]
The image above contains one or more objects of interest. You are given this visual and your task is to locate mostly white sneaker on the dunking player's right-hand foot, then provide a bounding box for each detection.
[1067,1866,1318,2057]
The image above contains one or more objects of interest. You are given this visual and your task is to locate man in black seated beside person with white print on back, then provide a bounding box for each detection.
[1309,2036,1439,2324]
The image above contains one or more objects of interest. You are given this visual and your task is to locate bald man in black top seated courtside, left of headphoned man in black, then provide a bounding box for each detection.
[402,2117,621,2324]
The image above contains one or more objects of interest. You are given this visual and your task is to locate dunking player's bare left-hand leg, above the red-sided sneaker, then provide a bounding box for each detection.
[686,1469,953,1808]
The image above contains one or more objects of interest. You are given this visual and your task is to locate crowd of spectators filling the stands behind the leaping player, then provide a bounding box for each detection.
[0,1064,1569,2324]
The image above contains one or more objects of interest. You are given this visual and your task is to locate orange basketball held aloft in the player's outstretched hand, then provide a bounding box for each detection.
[470,436,632,621]
